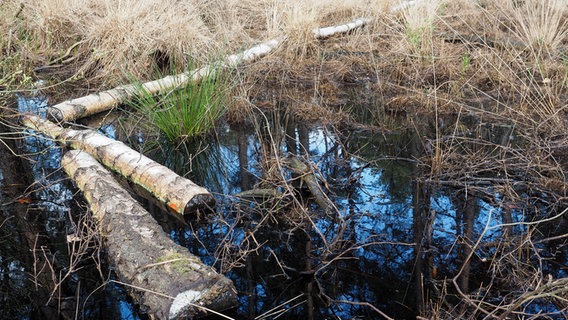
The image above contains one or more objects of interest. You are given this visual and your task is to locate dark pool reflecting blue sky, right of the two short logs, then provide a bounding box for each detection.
[48,105,565,319]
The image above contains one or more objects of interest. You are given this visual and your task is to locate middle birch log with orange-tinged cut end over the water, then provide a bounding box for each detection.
[20,114,215,214]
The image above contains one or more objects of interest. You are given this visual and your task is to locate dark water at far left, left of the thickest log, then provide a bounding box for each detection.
[0,98,136,319]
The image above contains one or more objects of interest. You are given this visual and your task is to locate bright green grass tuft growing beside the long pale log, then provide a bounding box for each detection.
[128,65,232,142]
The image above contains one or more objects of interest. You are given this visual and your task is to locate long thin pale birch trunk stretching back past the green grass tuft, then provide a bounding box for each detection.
[47,18,371,122]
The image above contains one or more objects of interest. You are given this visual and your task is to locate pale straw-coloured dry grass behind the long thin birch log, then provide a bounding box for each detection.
[8,0,385,85]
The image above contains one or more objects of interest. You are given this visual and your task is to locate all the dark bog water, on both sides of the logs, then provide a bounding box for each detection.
[0,100,567,319]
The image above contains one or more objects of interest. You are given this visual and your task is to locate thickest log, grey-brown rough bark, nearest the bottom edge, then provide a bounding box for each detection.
[61,150,237,319]
